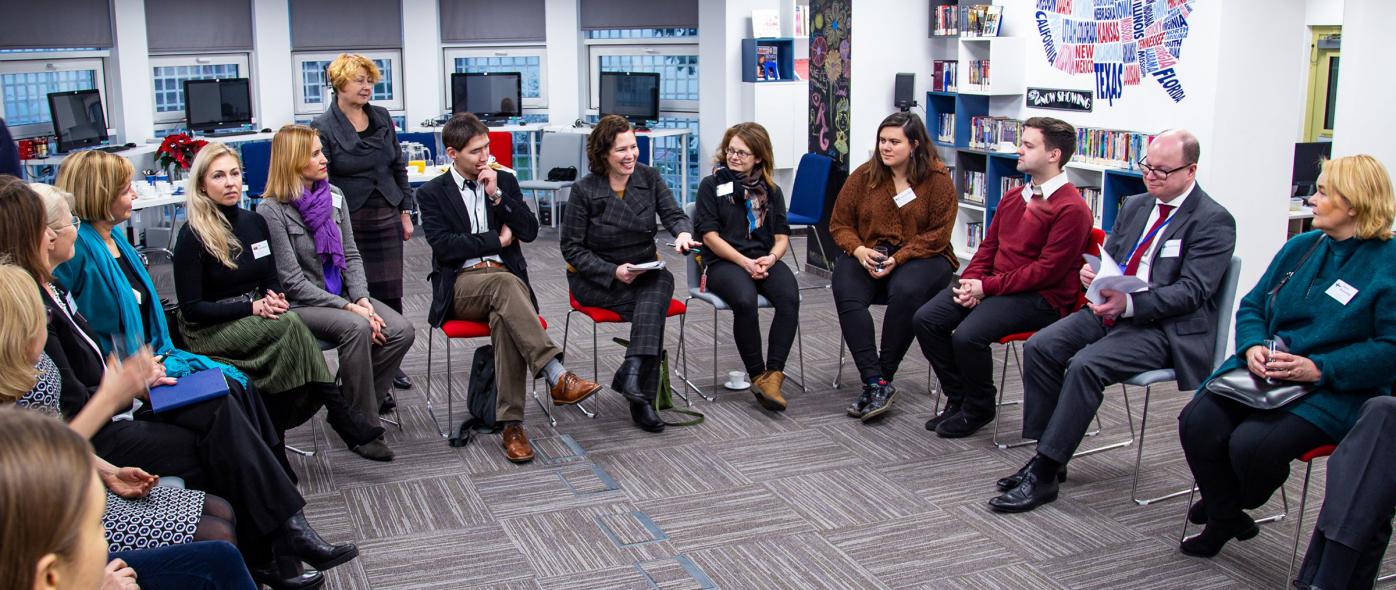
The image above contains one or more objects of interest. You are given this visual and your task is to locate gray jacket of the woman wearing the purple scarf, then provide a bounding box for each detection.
[257,184,369,308]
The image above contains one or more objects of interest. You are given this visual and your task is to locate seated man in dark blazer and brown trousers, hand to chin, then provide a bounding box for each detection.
[417,113,602,463]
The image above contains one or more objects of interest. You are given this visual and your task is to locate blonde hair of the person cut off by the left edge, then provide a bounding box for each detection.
[0,261,46,404]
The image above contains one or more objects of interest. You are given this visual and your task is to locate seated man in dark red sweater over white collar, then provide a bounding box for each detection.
[914,117,1092,438]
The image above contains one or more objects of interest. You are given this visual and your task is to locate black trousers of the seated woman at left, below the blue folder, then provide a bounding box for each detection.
[92,381,306,551]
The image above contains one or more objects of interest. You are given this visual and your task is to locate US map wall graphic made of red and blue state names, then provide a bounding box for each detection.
[1033,0,1194,106]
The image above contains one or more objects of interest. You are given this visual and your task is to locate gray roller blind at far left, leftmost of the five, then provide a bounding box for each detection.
[0,0,112,49]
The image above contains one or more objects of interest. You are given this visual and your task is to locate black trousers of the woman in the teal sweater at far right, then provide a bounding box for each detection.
[1178,392,1333,520]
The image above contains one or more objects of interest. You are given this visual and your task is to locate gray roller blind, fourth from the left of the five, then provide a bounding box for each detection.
[437,0,547,43]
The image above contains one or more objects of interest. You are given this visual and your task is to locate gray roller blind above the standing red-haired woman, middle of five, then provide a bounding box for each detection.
[289,0,402,52]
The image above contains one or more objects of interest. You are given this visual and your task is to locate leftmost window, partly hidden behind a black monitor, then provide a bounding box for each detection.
[0,52,112,137]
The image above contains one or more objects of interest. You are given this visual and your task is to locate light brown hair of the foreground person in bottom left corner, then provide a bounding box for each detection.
[0,407,96,589]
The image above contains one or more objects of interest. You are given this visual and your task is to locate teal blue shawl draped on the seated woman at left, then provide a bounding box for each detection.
[53,223,248,388]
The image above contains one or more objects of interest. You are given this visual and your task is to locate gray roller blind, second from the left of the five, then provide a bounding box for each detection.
[145,0,253,53]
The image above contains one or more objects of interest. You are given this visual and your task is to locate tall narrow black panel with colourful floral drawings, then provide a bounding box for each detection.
[807,0,853,271]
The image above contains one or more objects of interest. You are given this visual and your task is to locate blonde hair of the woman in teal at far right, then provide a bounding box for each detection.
[1323,153,1396,240]
